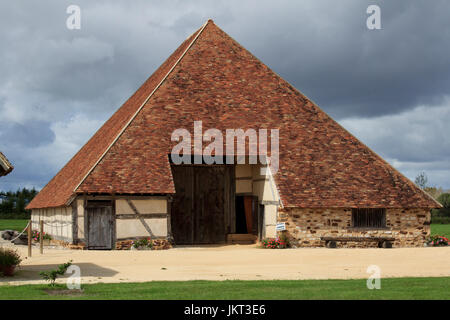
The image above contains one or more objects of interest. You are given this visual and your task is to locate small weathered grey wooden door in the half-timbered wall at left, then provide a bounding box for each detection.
[86,201,114,250]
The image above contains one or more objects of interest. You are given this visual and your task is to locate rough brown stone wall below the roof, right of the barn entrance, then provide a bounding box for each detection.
[278,208,431,247]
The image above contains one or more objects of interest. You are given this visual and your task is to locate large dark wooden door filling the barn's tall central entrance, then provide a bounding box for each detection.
[171,165,234,244]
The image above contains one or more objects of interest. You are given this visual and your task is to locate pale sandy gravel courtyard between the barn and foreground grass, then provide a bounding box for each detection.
[0,245,450,285]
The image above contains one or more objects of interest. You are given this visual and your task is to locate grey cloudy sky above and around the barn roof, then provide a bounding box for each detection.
[0,0,450,190]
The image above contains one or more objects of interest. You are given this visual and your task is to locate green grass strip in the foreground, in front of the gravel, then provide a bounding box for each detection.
[0,277,450,300]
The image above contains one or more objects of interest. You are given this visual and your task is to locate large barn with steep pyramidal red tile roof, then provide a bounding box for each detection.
[27,20,439,249]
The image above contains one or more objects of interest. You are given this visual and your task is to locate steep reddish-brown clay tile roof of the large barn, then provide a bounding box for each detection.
[28,20,439,209]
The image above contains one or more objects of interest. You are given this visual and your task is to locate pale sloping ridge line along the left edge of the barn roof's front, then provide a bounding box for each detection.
[68,19,214,199]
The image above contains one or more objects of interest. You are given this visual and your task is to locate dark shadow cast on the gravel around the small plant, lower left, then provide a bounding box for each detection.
[0,263,118,284]
